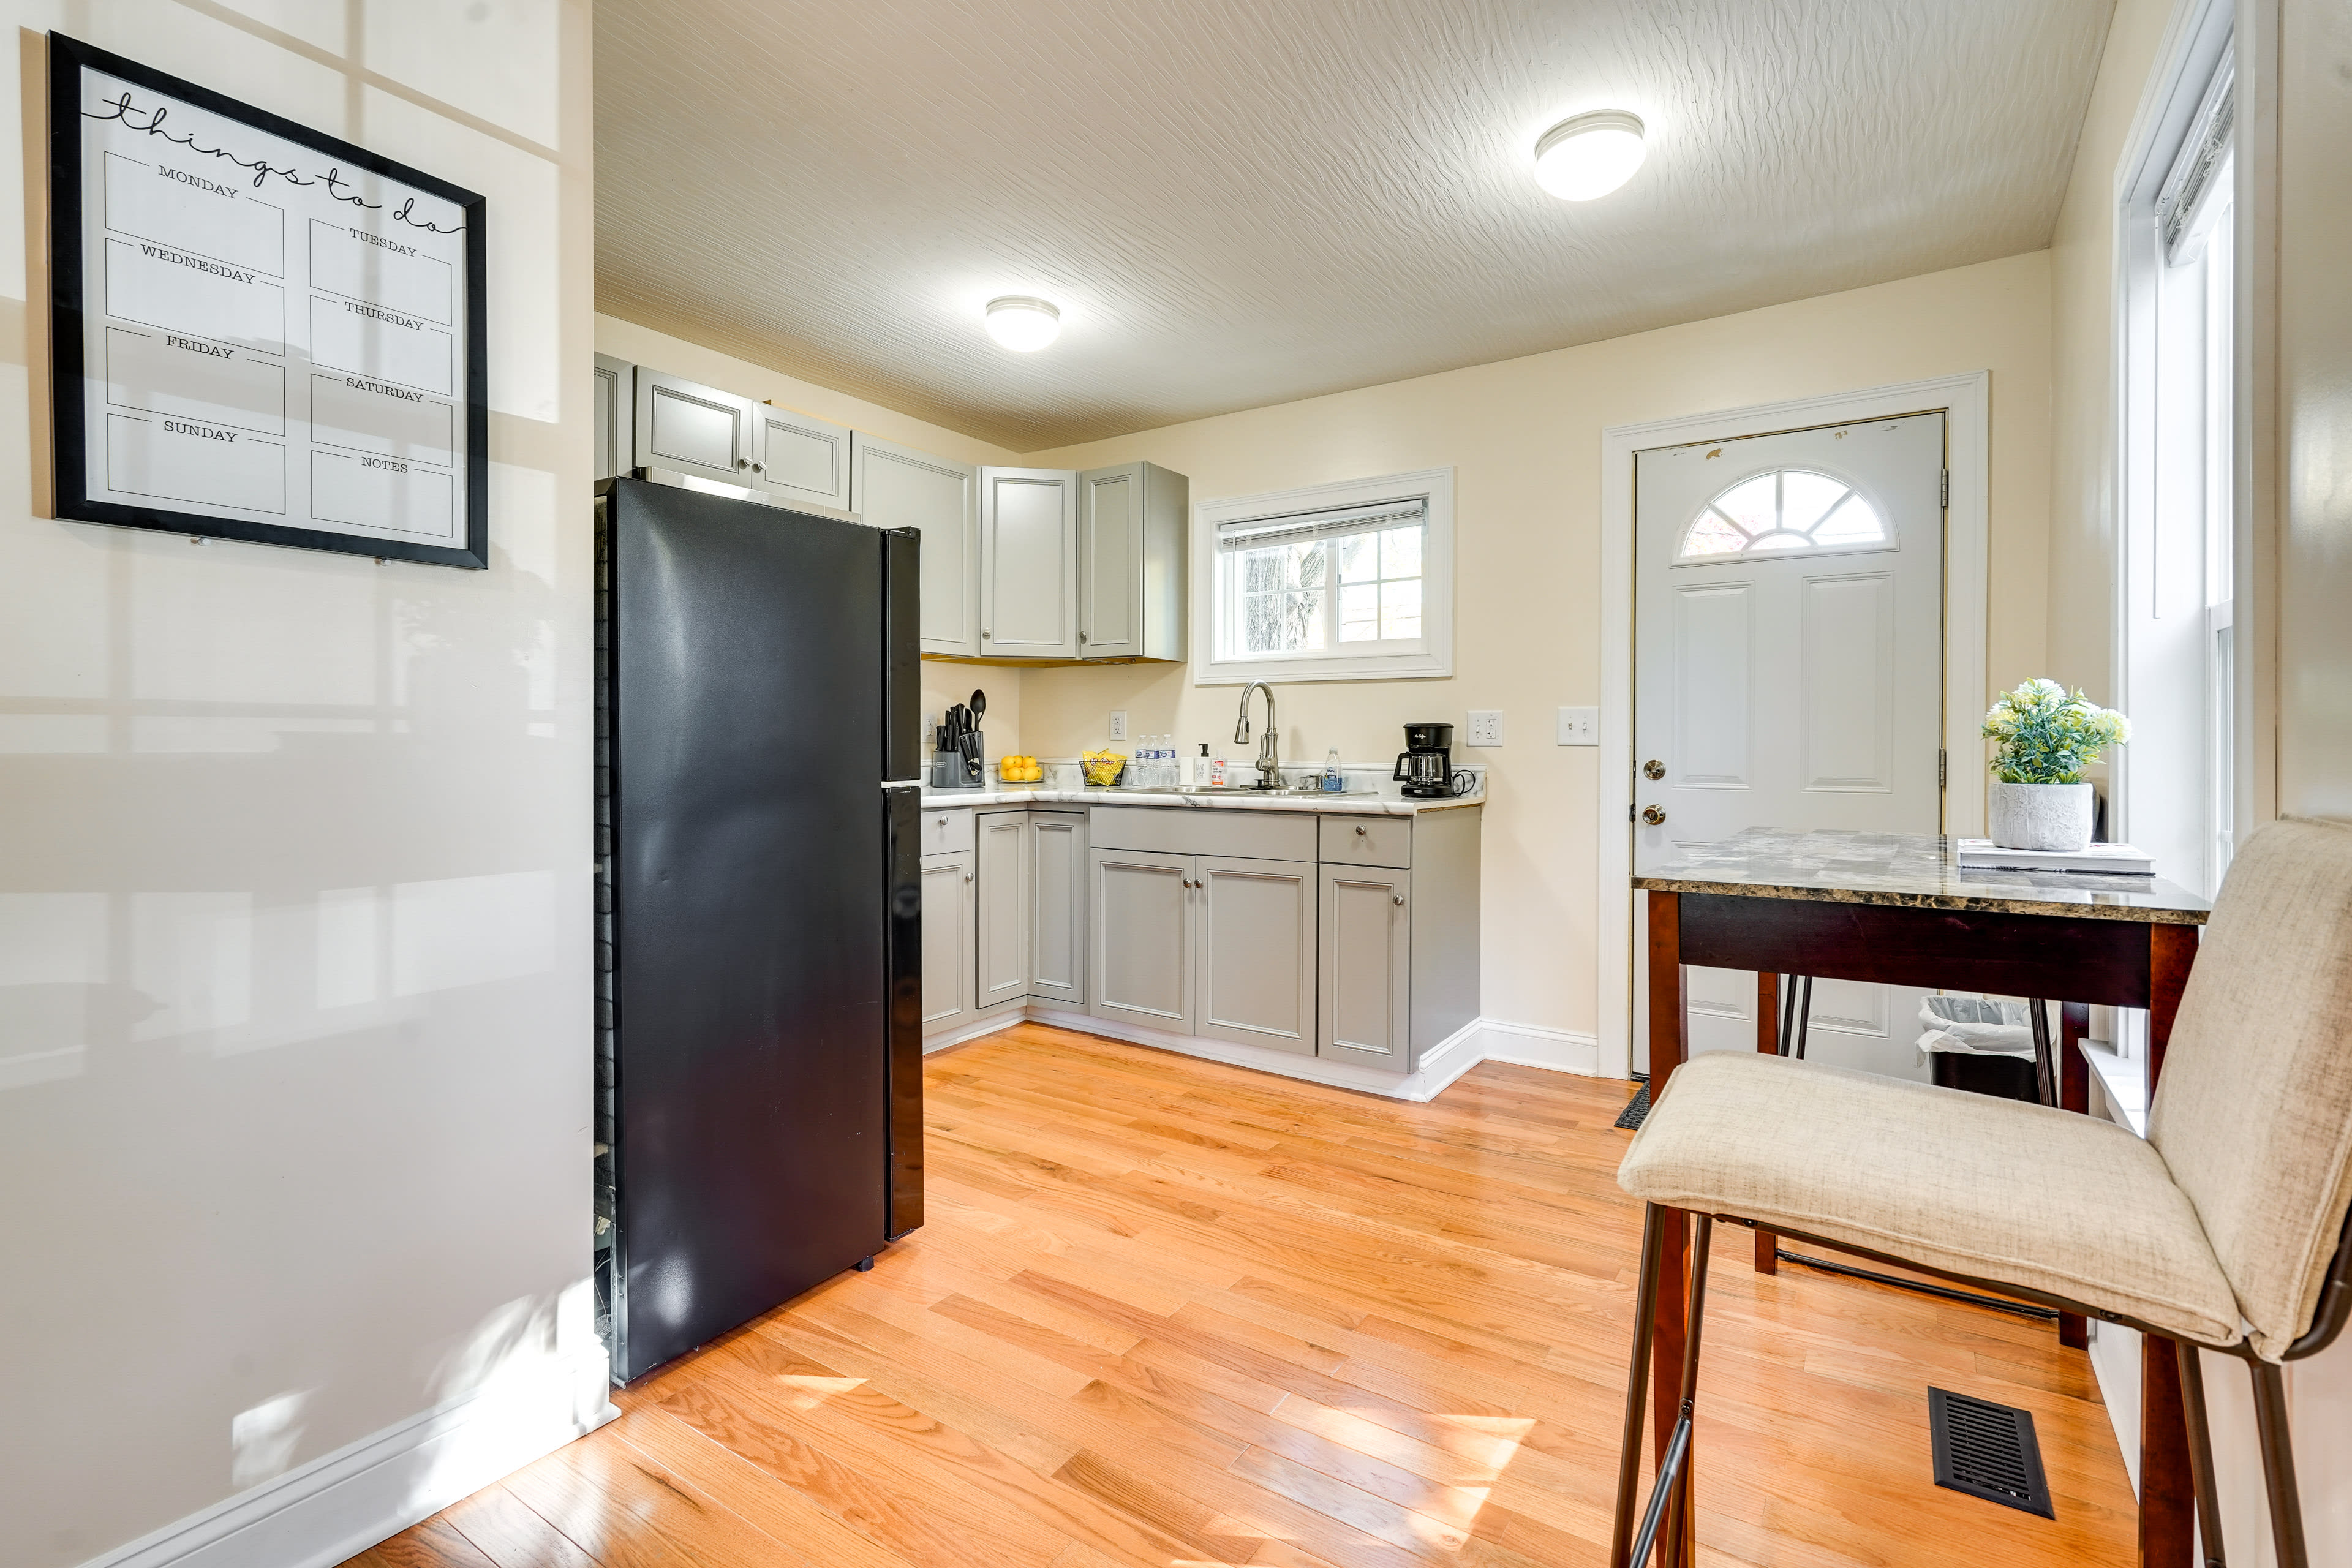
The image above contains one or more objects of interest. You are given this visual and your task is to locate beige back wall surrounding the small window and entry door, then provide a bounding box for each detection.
[1023,252,2051,1035]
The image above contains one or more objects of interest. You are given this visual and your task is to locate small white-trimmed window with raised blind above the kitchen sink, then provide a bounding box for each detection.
[1197,468,1453,684]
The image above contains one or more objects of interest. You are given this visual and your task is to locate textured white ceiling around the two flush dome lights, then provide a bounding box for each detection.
[595,0,2112,451]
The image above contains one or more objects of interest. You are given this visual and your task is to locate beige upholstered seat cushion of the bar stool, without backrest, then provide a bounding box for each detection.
[1618,1051,2239,1344]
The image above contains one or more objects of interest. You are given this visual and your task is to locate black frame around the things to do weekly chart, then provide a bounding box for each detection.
[50,33,489,571]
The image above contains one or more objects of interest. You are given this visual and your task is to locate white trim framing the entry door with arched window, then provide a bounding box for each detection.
[1595,371,1992,1079]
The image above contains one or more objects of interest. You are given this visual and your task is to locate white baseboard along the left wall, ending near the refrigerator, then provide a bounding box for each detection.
[82,1344,621,1568]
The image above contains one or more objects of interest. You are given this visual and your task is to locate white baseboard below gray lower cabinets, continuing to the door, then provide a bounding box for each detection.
[922,1004,1599,1105]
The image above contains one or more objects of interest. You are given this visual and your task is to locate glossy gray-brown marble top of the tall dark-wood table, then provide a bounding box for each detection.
[1632,827,2213,926]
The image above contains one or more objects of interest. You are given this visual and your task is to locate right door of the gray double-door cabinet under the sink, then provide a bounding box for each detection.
[1195,856,1315,1055]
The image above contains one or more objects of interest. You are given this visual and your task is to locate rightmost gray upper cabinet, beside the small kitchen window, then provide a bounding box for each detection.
[1077,463,1193,658]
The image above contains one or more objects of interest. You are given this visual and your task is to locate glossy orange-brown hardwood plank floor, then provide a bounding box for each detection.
[353,1025,2133,1568]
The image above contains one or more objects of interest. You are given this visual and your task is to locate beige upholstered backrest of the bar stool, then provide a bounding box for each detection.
[2147,820,2352,1361]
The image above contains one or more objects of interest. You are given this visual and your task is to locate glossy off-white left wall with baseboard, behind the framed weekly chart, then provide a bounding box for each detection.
[0,0,602,1568]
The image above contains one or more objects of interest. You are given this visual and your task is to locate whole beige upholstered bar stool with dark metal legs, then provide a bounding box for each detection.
[1611,820,2352,1568]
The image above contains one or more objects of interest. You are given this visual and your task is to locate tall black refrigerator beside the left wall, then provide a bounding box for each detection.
[595,480,922,1382]
